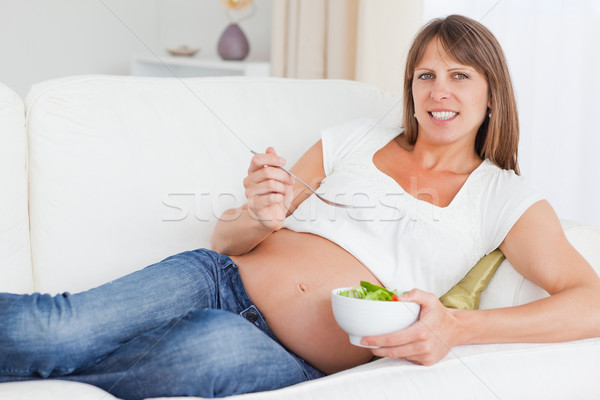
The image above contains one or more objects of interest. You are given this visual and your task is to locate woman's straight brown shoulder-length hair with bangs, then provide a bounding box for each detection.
[403,15,519,174]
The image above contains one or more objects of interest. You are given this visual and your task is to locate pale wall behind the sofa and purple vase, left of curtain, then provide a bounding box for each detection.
[0,0,272,96]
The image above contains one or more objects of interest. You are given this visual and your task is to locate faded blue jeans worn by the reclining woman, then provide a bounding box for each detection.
[0,249,323,399]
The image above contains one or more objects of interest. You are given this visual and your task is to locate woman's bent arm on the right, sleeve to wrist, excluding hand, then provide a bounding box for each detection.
[457,201,600,343]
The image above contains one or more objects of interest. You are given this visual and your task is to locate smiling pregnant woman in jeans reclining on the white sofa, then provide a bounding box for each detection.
[0,16,600,399]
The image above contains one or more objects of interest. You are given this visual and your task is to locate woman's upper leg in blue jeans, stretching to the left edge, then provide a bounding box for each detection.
[0,250,231,381]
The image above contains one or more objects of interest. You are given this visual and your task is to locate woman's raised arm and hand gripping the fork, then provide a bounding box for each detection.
[211,140,325,255]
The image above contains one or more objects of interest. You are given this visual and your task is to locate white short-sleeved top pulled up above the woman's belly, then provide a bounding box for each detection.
[284,119,542,297]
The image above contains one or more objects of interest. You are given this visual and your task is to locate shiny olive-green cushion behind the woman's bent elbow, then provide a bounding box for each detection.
[440,249,505,310]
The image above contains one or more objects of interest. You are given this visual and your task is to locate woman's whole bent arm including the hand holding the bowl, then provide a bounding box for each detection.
[365,201,600,365]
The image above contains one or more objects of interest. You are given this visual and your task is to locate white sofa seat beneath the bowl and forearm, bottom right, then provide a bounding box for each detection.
[213,338,600,400]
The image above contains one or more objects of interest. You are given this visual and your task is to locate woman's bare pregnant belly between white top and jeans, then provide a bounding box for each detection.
[232,229,379,374]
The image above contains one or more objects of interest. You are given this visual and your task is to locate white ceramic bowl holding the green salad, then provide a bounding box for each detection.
[331,288,421,347]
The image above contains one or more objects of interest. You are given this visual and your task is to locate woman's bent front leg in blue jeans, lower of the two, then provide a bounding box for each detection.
[60,310,315,400]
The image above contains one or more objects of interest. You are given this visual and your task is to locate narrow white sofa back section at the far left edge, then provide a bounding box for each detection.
[0,83,32,293]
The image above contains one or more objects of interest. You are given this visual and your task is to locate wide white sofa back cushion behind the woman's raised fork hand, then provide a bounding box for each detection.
[26,76,402,293]
